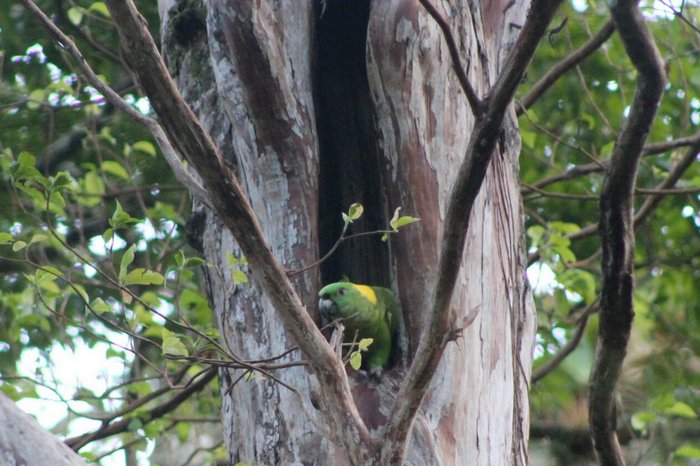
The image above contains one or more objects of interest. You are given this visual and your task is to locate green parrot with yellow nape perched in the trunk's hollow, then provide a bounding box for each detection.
[318,281,398,375]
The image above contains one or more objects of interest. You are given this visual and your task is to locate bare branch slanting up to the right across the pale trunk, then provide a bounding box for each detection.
[381,0,561,464]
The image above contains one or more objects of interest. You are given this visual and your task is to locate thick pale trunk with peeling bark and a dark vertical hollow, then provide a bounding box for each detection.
[160,0,535,465]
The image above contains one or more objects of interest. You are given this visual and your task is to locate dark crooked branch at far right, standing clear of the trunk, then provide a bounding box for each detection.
[588,0,666,465]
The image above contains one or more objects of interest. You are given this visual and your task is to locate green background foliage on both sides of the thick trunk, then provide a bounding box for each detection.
[0,0,700,464]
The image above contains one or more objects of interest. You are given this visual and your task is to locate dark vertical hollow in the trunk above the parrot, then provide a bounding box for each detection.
[315,0,390,287]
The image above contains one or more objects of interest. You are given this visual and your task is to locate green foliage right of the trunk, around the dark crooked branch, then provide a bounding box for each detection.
[520,1,700,464]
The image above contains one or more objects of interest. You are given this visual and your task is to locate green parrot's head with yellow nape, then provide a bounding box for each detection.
[318,282,377,322]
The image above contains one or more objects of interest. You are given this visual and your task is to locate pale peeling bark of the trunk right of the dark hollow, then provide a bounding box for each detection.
[369,1,534,464]
